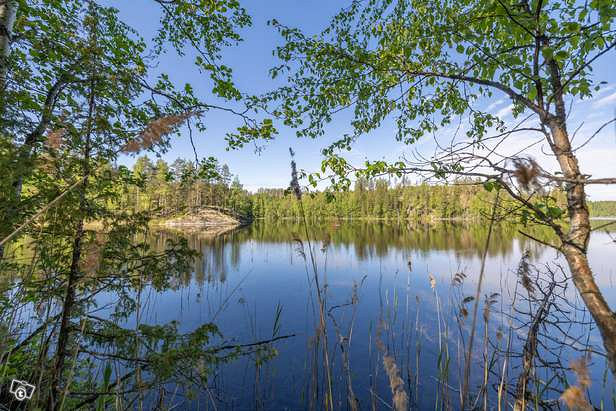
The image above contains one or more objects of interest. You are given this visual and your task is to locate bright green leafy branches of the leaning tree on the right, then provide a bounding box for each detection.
[268,0,616,154]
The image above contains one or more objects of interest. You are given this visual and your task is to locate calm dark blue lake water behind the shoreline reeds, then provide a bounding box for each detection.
[113,221,616,410]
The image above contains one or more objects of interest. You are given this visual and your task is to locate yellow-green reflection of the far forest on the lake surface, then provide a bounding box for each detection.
[151,221,549,285]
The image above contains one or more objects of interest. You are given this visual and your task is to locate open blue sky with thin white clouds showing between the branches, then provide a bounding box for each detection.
[112,0,616,200]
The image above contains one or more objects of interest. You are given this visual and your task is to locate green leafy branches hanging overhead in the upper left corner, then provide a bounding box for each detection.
[1,0,275,166]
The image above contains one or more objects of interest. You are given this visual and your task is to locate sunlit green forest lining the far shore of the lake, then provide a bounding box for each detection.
[116,157,616,221]
